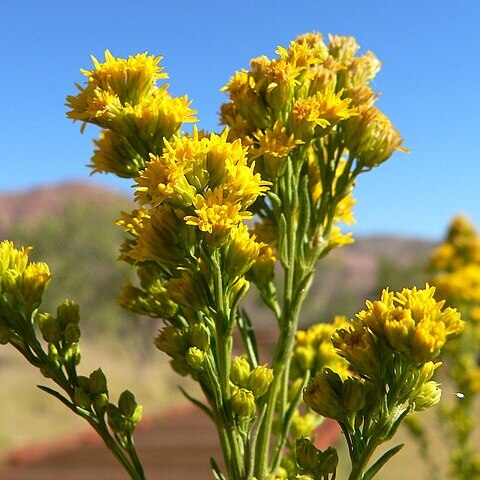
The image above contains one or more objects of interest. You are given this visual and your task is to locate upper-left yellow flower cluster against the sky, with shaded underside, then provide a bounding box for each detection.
[67,50,196,178]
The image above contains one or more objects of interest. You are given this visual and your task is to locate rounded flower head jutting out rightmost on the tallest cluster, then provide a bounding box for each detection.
[344,106,407,168]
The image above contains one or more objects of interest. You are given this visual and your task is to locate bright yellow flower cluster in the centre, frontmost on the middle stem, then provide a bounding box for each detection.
[137,129,270,244]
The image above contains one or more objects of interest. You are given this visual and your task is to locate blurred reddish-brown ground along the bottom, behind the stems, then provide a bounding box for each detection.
[0,408,338,480]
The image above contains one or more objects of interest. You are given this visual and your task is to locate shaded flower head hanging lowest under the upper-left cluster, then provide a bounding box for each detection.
[87,130,145,178]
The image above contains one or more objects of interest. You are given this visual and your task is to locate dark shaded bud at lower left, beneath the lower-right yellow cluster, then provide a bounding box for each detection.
[303,368,343,419]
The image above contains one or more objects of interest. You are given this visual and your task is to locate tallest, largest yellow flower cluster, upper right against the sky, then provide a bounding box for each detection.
[221,33,402,179]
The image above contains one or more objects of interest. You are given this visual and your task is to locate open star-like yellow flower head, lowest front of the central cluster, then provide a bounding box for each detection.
[184,187,252,243]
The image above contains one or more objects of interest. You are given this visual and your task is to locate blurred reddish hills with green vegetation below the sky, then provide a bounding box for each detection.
[0,183,433,330]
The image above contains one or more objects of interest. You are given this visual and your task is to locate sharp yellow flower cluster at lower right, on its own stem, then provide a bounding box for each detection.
[332,285,463,366]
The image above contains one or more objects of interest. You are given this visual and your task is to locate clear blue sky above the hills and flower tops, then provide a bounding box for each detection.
[0,0,480,239]
